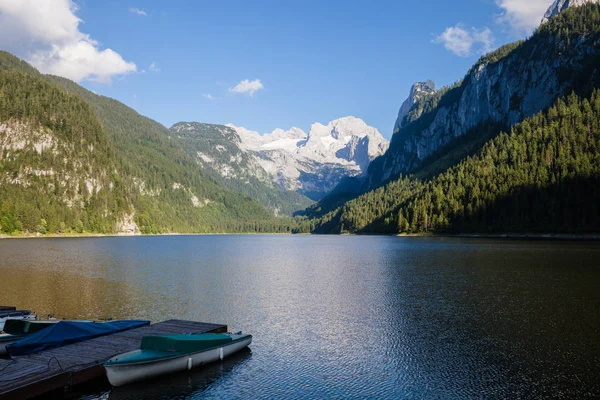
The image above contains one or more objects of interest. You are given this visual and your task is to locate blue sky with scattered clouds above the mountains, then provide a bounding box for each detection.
[0,0,551,138]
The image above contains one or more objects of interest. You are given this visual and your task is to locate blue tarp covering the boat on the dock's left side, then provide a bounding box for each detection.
[6,320,150,356]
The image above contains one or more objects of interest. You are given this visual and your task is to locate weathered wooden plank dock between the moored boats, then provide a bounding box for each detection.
[0,320,227,400]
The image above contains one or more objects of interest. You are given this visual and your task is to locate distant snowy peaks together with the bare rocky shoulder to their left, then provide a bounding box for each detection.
[171,117,389,199]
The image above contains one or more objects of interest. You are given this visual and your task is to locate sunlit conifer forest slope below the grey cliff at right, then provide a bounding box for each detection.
[302,91,600,233]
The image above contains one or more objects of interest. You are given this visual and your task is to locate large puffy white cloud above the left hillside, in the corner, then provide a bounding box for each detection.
[0,0,137,83]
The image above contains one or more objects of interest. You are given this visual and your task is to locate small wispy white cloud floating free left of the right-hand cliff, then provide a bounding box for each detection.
[433,24,495,57]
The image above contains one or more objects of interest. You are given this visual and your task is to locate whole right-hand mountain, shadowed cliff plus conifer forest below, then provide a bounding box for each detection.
[301,4,600,233]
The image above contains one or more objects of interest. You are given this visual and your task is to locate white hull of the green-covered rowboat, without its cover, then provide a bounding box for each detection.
[104,336,252,386]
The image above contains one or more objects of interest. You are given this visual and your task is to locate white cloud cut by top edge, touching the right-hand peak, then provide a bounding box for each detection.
[496,0,552,35]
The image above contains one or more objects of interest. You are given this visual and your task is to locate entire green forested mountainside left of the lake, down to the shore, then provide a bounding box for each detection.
[0,53,283,233]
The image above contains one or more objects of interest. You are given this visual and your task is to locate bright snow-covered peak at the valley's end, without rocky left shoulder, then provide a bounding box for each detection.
[228,117,389,199]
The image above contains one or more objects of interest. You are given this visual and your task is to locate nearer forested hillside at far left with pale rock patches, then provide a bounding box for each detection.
[0,61,130,233]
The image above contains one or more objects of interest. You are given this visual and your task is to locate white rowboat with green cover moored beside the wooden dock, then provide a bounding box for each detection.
[104,332,252,386]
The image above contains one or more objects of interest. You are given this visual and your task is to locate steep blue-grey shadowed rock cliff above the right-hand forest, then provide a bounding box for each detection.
[367,2,600,187]
